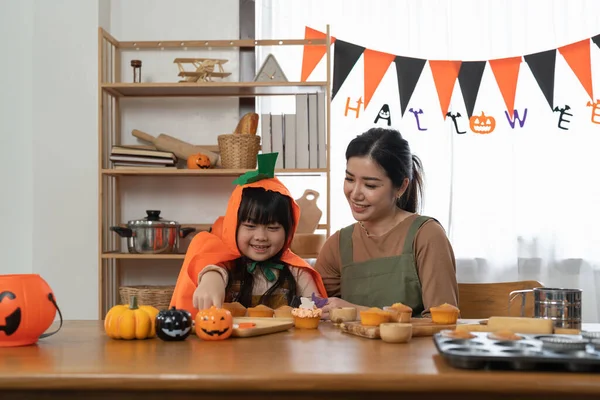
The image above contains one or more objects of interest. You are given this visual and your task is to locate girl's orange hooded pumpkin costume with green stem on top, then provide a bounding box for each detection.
[170,153,327,315]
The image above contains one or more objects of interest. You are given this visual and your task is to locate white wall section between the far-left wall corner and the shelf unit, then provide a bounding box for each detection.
[31,0,99,319]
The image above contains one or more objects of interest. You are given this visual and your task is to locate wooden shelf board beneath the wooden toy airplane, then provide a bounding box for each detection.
[102,82,327,97]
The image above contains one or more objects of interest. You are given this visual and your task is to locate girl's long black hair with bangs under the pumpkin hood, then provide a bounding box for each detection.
[225,187,296,307]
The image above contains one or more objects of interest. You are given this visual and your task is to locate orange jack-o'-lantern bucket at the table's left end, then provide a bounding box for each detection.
[0,274,62,347]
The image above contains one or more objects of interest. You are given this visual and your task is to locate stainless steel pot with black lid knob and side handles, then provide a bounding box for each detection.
[110,210,196,254]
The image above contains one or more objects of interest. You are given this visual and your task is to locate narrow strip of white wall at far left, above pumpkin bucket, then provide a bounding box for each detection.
[0,0,34,274]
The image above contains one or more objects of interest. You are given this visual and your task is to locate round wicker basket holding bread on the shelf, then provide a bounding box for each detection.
[217,134,260,169]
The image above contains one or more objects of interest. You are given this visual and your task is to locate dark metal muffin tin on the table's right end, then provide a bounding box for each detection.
[433,332,600,372]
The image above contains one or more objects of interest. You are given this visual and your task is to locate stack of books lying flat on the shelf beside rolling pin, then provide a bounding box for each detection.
[110,146,177,169]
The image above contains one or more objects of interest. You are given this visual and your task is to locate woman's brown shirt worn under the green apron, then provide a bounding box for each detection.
[315,214,458,314]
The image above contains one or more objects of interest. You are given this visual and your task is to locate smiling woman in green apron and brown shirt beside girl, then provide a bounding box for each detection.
[315,128,458,318]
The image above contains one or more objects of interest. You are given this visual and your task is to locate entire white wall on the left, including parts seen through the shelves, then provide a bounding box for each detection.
[0,0,239,319]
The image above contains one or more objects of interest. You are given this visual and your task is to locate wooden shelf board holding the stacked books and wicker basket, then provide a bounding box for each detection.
[101,168,327,176]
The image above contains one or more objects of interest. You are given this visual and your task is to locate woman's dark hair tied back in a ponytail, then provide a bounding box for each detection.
[346,128,423,213]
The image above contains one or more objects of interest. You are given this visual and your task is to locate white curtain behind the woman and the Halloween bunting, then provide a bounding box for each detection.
[256,0,600,322]
